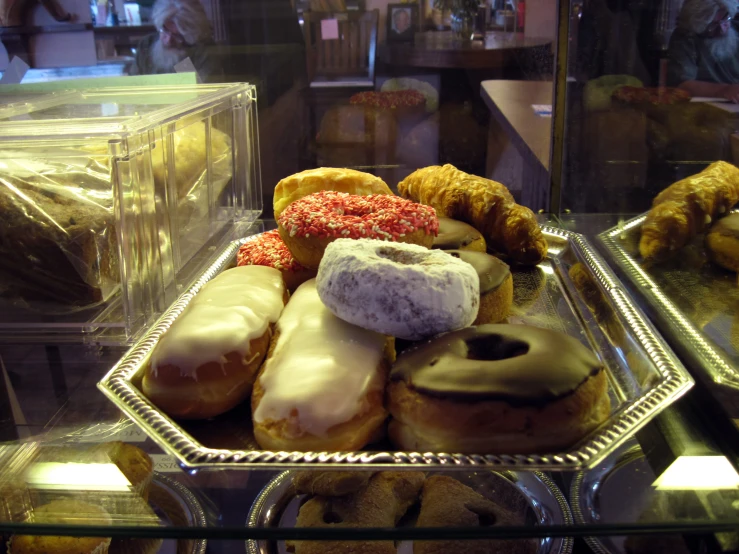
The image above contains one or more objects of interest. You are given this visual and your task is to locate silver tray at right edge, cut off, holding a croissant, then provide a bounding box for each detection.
[598,214,739,389]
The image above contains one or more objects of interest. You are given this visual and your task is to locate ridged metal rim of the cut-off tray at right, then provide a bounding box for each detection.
[598,213,739,389]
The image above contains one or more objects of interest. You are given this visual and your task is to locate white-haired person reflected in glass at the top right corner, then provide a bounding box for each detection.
[667,0,739,103]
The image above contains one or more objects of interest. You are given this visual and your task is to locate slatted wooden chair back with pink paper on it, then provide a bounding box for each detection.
[303,10,380,88]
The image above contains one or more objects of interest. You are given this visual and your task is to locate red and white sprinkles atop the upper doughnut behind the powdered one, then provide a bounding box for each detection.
[278,190,439,241]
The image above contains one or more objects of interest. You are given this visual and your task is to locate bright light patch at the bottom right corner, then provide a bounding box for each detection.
[652,456,739,490]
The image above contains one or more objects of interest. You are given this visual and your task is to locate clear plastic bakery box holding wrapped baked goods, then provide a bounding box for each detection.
[0,84,262,343]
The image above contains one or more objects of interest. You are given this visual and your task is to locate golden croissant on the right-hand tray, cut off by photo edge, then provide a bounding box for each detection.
[639,158,739,261]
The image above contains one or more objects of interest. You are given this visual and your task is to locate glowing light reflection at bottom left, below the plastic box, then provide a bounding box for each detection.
[26,462,131,492]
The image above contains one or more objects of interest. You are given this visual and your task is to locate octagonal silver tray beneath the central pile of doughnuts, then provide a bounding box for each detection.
[98,227,693,471]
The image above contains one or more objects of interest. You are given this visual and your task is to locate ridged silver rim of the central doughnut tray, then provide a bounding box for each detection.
[98,227,694,471]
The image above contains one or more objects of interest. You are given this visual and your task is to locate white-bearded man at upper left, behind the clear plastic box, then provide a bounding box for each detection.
[129,0,222,82]
